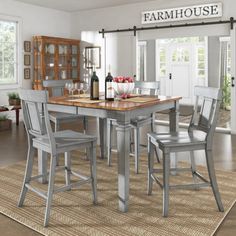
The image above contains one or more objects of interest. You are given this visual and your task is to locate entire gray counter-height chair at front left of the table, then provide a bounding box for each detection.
[18,90,97,227]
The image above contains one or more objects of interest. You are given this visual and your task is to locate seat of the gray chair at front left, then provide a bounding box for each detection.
[33,130,97,153]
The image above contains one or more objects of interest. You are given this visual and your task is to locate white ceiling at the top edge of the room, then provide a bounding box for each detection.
[15,0,154,12]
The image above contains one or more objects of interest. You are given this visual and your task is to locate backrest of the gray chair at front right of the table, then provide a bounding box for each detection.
[189,86,222,145]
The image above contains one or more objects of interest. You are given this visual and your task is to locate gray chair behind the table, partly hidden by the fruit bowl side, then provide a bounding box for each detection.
[107,81,160,174]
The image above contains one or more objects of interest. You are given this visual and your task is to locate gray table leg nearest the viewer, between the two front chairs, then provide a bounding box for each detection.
[116,123,131,212]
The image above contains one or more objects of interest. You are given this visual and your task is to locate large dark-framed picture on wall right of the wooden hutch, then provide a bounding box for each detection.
[85,46,101,69]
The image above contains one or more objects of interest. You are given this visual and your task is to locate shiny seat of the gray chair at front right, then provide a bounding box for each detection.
[148,130,206,147]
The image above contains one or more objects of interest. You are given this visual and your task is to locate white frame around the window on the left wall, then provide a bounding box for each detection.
[0,14,23,91]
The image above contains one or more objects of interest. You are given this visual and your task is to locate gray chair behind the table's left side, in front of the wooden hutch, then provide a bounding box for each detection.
[43,79,88,133]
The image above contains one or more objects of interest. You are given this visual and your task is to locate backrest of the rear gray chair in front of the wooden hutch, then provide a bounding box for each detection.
[43,79,73,97]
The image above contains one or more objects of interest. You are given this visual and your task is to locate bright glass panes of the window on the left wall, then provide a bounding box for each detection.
[0,16,19,88]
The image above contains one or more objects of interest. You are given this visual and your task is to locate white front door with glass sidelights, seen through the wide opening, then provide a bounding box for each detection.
[156,37,208,104]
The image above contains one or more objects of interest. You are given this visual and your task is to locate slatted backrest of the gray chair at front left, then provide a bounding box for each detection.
[19,89,56,154]
